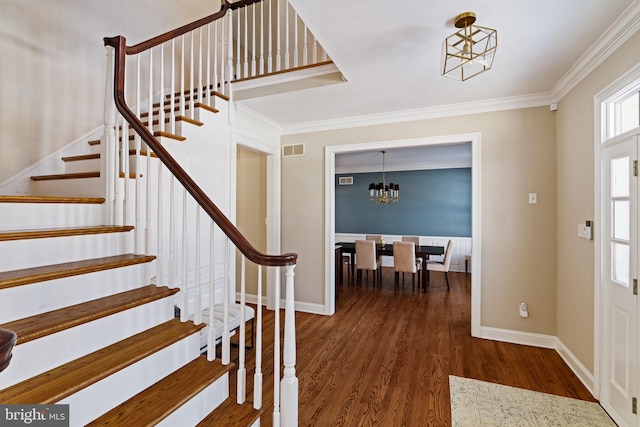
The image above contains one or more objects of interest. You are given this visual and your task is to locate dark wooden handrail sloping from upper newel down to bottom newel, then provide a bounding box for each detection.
[104,36,298,266]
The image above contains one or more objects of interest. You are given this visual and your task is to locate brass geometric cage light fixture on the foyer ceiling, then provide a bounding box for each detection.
[441,12,498,81]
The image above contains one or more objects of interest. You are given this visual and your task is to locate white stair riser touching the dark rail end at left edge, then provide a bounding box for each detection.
[0,298,175,390]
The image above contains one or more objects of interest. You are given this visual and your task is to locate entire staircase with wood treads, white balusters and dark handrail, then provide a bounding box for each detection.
[0,0,316,427]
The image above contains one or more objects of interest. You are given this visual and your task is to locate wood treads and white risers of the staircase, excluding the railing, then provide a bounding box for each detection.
[0,98,262,426]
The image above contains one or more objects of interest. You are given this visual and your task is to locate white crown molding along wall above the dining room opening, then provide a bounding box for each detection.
[282,93,552,135]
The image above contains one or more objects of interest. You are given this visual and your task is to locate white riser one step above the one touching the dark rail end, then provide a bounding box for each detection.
[0,263,151,323]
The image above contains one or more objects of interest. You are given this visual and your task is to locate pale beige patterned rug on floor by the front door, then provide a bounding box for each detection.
[449,375,615,427]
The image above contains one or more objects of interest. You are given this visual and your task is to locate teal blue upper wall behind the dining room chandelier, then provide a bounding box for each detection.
[335,168,471,237]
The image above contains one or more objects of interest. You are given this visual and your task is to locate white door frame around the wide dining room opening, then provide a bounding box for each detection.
[324,132,482,337]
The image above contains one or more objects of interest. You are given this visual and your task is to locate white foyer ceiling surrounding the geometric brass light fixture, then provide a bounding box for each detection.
[241,0,640,131]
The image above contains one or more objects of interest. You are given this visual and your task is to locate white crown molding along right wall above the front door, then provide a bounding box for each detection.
[551,0,640,102]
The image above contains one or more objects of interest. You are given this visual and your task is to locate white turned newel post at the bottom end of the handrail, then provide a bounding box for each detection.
[280,265,298,427]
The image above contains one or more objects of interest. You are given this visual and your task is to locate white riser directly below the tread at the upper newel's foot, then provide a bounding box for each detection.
[0,203,104,230]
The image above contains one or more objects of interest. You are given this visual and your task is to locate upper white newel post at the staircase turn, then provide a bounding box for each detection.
[100,46,116,224]
